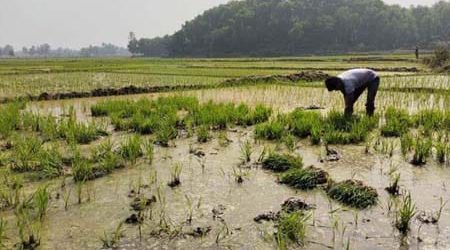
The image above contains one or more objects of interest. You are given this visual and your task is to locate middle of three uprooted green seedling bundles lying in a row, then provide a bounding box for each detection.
[280,166,328,190]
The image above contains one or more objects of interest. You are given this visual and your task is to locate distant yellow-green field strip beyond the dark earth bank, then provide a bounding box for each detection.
[0,55,432,98]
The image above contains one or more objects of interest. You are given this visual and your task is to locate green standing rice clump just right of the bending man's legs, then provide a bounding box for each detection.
[381,107,411,137]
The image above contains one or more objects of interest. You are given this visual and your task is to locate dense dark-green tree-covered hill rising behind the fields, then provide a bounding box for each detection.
[128,0,450,57]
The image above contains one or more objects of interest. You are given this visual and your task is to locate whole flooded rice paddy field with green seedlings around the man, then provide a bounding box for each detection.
[0,55,450,249]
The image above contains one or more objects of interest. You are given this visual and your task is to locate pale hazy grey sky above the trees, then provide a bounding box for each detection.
[0,0,438,49]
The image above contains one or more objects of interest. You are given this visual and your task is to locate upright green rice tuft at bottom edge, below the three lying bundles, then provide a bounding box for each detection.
[275,211,311,249]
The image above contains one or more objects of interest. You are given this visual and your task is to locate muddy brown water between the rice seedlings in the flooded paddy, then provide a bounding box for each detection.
[2,86,450,249]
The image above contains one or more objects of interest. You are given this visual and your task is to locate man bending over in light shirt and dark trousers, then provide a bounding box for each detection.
[325,69,380,116]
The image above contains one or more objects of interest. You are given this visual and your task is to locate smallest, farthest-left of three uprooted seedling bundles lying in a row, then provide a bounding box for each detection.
[262,153,303,172]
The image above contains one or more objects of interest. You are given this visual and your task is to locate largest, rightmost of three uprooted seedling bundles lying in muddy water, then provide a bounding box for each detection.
[328,180,378,209]
